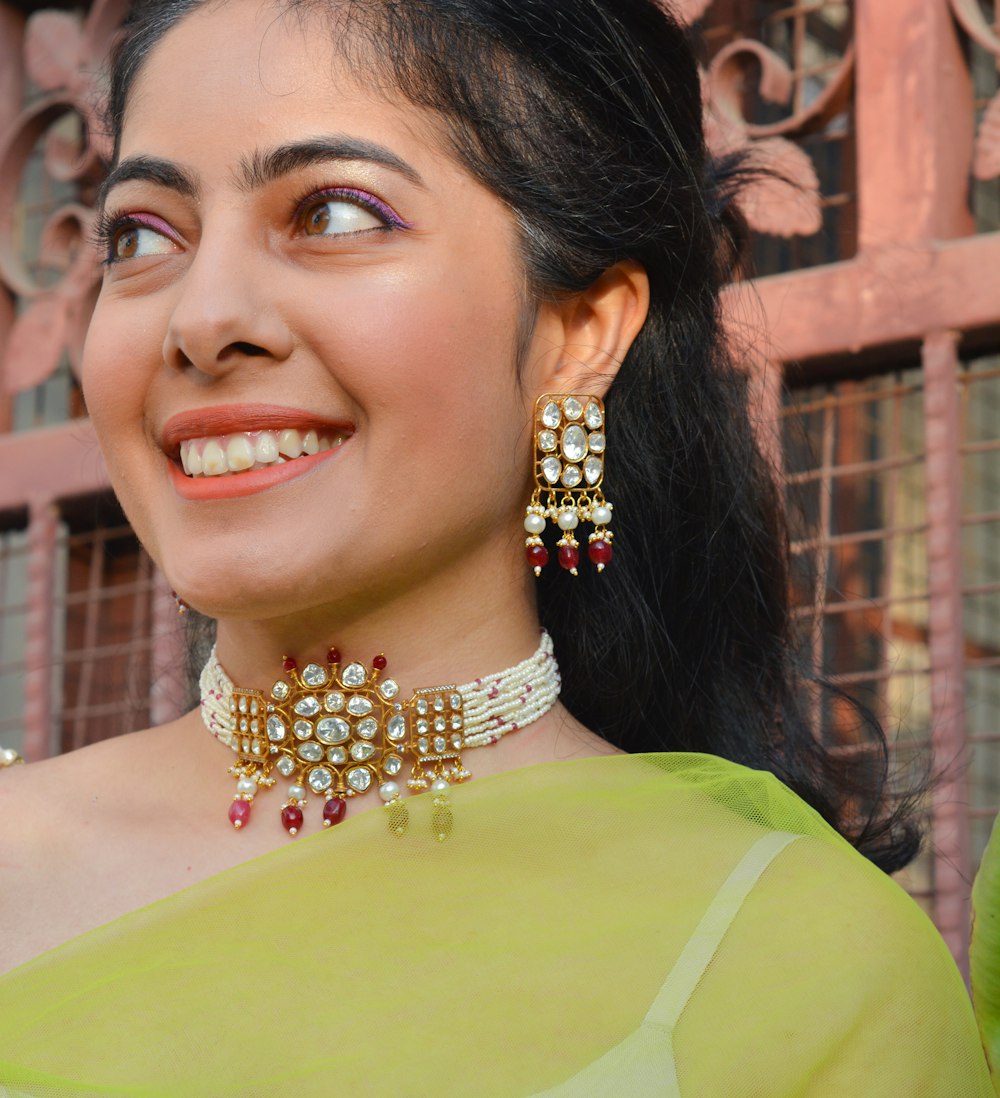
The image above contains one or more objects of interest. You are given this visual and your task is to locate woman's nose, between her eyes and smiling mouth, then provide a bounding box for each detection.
[164,229,293,377]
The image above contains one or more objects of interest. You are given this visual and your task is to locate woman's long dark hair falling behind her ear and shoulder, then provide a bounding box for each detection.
[109,0,919,871]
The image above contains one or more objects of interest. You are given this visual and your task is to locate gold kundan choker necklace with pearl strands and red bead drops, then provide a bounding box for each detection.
[201,630,561,839]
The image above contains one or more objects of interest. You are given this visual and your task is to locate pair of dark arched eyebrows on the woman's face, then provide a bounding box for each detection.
[98,136,427,209]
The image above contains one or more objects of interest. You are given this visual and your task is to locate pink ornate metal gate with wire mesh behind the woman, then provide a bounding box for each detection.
[0,0,1000,967]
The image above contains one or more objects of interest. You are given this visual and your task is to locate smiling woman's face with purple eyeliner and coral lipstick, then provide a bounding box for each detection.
[83,0,550,617]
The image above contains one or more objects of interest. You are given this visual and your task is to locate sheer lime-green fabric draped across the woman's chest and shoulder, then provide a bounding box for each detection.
[0,754,993,1098]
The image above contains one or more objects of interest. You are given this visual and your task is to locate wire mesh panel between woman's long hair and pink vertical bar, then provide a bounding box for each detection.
[783,369,933,904]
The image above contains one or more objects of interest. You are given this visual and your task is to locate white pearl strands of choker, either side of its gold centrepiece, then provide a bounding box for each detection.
[200,630,562,749]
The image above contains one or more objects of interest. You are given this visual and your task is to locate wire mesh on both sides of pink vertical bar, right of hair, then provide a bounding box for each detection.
[783,357,1000,908]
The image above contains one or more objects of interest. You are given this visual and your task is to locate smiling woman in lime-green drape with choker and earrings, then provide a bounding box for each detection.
[0,0,990,1098]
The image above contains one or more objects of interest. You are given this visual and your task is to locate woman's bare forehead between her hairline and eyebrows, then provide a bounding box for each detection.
[121,0,446,163]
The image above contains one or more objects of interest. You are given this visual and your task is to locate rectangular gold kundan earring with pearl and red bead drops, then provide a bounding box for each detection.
[525,393,614,575]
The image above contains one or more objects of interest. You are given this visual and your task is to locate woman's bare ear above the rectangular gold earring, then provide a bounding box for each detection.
[529,259,650,397]
